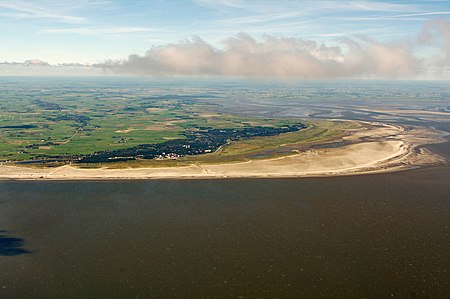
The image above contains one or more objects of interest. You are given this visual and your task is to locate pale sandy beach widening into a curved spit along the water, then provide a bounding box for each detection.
[0,123,445,180]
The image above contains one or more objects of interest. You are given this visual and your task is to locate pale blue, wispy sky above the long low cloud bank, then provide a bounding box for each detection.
[0,0,450,63]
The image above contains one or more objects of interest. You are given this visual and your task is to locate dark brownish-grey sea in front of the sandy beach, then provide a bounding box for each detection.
[0,143,450,298]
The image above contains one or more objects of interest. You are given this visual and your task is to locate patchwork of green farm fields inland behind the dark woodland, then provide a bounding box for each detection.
[0,84,282,161]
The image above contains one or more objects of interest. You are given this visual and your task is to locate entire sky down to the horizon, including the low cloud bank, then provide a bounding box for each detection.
[0,0,450,79]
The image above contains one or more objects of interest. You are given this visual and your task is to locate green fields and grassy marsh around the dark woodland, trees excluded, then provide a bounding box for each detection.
[0,79,349,167]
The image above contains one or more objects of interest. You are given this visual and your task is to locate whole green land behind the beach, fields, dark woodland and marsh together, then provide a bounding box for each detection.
[0,81,352,165]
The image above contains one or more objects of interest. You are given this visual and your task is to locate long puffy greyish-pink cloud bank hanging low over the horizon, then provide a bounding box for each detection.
[95,20,450,79]
